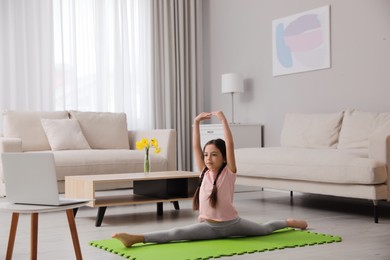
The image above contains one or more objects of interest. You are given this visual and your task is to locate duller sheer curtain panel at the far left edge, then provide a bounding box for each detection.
[0,0,53,114]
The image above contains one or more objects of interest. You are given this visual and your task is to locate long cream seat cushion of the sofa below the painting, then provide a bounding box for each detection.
[235,147,387,185]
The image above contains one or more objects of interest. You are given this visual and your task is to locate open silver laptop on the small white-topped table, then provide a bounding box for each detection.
[1,153,89,206]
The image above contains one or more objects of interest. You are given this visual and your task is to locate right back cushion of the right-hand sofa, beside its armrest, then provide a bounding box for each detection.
[337,109,390,149]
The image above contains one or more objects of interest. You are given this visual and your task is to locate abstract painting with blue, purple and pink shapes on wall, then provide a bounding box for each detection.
[272,5,330,76]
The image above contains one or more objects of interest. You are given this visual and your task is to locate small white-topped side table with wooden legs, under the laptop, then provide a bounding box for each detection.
[0,202,88,260]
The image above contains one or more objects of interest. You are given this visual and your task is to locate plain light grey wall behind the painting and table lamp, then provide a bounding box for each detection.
[203,0,390,146]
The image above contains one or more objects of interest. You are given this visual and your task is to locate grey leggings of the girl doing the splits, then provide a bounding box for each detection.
[144,218,287,243]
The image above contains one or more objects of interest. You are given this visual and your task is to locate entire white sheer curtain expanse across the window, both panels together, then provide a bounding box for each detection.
[0,0,154,129]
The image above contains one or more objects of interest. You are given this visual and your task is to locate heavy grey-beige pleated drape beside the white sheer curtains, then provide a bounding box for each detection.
[153,0,202,170]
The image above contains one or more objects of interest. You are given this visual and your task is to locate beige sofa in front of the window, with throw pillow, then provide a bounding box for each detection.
[0,111,177,196]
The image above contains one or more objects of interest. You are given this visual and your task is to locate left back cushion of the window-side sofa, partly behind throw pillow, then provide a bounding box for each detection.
[3,111,68,151]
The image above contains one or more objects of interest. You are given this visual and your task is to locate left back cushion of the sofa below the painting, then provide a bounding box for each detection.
[280,112,343,148]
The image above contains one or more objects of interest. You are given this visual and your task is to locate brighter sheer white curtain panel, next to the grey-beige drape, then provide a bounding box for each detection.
[54,0,153,129]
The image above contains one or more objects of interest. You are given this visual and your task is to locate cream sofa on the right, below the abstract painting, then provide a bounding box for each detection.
[236,109,390,222]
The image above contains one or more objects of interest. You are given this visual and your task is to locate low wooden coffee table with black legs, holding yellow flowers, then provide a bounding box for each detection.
[65,171,199,227]
